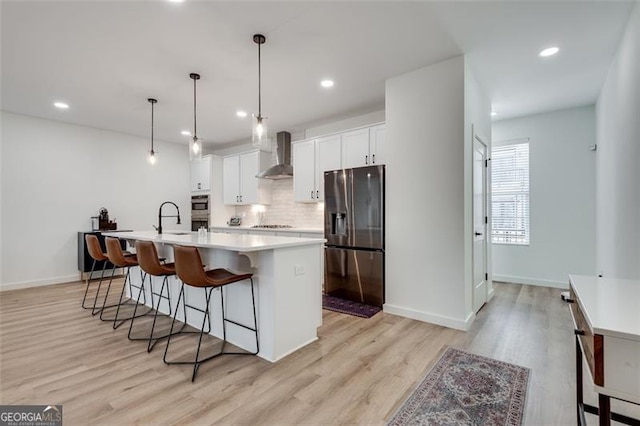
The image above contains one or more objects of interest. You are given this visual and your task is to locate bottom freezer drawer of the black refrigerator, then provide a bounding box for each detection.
[324,247,384,307]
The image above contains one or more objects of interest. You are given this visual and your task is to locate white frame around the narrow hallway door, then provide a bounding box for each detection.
[471,124,491,314]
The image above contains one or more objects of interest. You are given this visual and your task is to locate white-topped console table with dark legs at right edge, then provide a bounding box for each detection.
[569,275,640,425]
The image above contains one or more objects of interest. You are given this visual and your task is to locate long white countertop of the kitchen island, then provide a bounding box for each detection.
[102,230,324,252]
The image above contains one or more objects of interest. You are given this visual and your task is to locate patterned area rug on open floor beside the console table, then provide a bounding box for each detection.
[388,348,529,426]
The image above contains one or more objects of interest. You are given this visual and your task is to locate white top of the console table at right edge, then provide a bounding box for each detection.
[569,275,640,341]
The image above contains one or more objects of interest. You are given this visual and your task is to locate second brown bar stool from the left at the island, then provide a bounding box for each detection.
[100,237,153,330]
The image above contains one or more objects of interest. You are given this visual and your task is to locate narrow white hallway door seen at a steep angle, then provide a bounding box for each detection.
[472,132,488,312]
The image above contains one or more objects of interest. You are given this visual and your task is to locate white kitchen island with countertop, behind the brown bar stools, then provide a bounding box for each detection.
[103,231,324,362]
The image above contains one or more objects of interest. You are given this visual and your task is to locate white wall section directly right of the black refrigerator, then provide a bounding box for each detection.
[384,57,468,328]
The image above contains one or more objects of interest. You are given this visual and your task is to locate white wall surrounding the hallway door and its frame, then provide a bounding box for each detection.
[464,60,493,316]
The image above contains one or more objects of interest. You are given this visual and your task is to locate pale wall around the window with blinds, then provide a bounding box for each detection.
[492,106,599,288]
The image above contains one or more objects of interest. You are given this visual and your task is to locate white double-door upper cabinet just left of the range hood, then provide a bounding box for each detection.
[222,151,271,205]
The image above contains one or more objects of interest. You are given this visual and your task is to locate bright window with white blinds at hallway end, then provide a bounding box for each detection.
[491,138,529,245]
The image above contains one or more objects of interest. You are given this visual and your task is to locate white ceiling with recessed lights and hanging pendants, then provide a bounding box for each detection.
[0,0,637,148]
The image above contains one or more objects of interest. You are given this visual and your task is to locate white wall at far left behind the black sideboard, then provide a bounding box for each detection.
[0,112,190,289]
